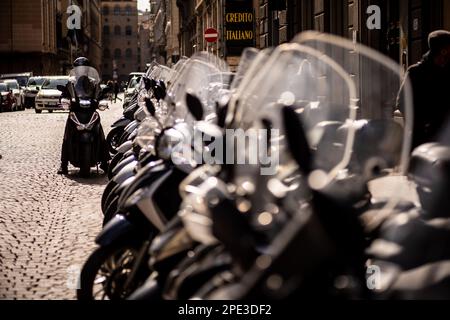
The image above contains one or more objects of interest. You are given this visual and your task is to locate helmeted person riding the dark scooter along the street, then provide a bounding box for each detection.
[58,57,110,178]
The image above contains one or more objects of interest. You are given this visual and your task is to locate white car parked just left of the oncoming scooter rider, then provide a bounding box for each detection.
[35,76,69,113]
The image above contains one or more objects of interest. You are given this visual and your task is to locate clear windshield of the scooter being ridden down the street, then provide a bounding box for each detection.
[69,66,100,99]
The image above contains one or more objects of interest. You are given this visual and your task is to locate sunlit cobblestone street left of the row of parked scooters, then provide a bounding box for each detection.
[0,97,122,299]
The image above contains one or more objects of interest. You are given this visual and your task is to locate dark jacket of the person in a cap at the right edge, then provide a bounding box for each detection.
[400,54,450,148]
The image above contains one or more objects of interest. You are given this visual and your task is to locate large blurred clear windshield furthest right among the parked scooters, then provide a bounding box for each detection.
[293,32,413,187]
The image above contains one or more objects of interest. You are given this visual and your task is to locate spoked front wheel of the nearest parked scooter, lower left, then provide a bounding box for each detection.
[77,243,139,300]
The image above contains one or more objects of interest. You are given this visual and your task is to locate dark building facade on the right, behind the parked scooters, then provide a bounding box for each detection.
[177,0,450,68]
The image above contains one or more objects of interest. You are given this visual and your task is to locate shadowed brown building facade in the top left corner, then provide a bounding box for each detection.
[0,0,102,75]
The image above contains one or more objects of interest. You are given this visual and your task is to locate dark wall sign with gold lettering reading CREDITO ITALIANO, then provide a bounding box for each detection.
[224,0,256,56]
